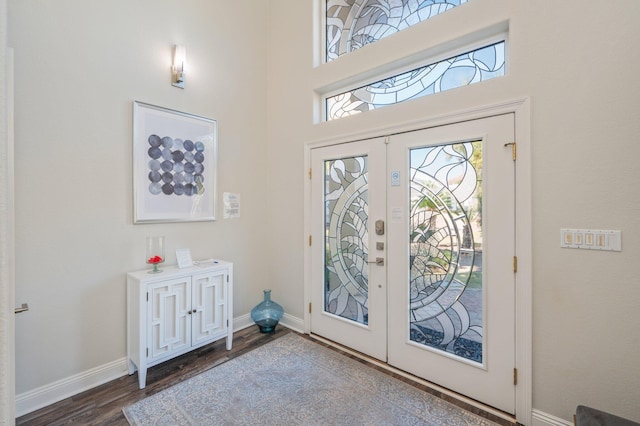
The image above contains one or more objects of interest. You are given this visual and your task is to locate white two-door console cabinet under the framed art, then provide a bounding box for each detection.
[127,261,233,389]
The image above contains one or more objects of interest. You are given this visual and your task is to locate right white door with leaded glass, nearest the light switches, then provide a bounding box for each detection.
[387,114,515,414]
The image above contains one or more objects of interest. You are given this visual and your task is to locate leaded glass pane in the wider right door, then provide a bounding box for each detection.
[409,142,483,362]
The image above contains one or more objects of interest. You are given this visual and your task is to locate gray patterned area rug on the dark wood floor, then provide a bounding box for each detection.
[123,333,495,426]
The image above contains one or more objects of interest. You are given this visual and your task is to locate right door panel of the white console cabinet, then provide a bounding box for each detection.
[192,271,227,345]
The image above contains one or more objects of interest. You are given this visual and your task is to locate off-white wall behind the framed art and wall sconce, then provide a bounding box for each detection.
[8,0,268,394]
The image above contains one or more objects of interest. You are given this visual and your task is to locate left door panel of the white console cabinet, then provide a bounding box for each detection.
[148,277,191,361]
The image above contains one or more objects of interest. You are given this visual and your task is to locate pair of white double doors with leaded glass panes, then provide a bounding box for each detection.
[311,114,515,414]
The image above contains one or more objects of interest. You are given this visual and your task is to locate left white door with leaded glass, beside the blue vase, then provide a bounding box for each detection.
[311,138,387,361]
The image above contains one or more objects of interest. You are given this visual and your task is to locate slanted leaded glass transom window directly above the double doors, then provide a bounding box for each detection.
[326,41,505,121]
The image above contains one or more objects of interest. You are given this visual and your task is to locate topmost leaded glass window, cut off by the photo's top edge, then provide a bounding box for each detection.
[326,0,467,62]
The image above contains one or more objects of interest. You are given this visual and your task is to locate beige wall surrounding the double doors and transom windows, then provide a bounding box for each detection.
[269,0,640,421]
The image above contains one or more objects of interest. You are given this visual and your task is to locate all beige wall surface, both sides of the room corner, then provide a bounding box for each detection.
[8,0,640,421]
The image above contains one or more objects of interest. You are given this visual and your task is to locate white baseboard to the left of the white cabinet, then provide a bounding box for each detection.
[16,358,128,417]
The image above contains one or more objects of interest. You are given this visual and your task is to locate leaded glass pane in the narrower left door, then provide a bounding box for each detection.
[324,156,369,324]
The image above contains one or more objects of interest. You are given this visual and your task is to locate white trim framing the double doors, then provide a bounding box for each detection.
[304,98,533,425]
